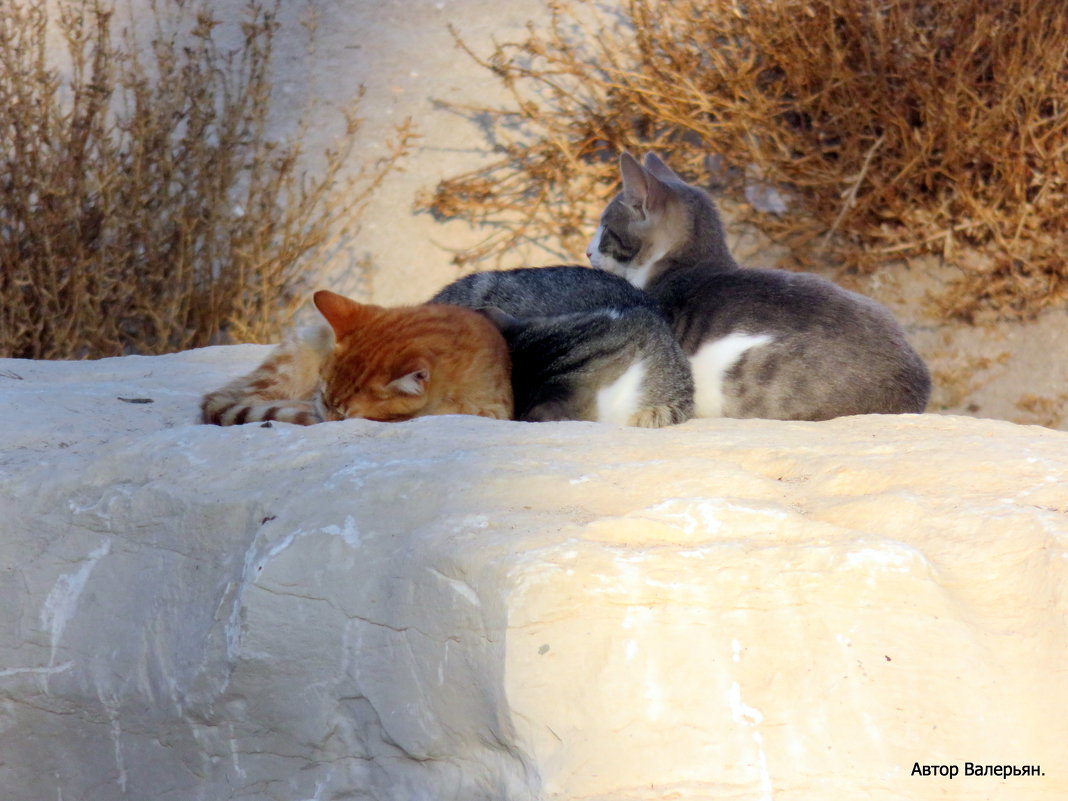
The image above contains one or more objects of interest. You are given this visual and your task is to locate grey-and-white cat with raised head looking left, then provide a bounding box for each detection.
[586,153,930,420]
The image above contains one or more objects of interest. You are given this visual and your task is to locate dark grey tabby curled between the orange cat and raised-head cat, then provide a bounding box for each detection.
[430,266,693,428]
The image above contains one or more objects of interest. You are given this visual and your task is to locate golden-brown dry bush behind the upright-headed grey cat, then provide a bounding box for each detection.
[425,0,1068,317]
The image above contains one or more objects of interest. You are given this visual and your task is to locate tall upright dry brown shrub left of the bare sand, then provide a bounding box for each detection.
[0,0,410,359]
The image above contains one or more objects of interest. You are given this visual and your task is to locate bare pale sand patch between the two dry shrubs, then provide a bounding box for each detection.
[209,0,559,304]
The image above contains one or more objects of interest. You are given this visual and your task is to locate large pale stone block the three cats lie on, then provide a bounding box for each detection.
[0,346,1068,801]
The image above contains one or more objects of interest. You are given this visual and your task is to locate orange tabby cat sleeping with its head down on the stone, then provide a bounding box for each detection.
[201,289,513,425]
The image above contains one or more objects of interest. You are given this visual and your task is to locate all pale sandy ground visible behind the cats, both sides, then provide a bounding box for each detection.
[110,0,1068,428]
